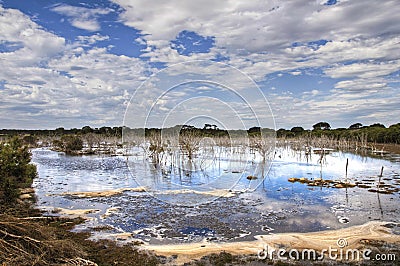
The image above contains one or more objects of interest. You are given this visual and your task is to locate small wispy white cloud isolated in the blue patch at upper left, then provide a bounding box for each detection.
[51,4,112,31]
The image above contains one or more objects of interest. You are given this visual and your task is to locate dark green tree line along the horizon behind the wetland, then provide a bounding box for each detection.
[0,122,400,144]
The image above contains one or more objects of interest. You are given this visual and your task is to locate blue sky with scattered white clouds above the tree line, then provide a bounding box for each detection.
[0,0,400,129]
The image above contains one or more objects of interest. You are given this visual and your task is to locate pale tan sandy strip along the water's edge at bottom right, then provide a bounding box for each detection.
[145,222,400,264]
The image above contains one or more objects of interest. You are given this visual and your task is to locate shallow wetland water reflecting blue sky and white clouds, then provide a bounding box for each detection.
[32,148,400,243]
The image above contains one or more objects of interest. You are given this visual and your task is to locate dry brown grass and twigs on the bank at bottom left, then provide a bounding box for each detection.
[0,207,160,265]
